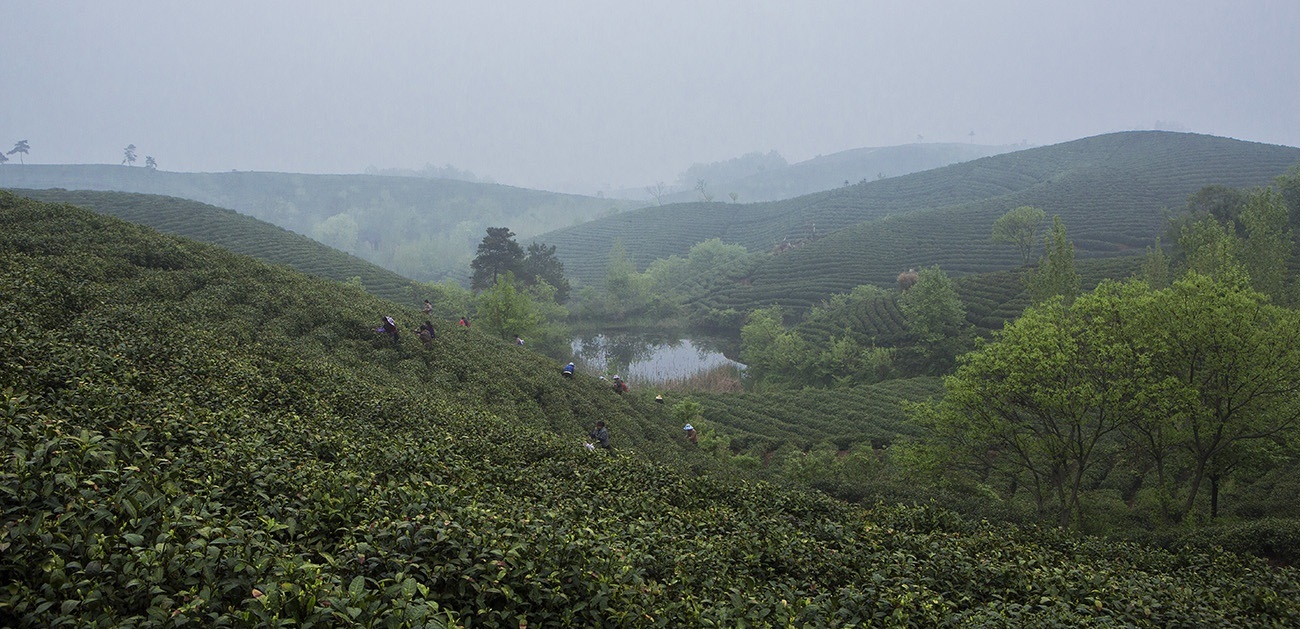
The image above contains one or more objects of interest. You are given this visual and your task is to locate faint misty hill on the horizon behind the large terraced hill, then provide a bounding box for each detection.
[616,143,1019,204]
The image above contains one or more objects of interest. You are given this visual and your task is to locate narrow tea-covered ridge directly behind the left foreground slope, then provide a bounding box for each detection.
[12,189,423,303]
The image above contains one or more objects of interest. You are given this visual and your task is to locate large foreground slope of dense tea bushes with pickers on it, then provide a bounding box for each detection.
[0,193,1299,628]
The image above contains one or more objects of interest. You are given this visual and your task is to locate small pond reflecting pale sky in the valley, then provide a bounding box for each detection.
[571,331,745,383]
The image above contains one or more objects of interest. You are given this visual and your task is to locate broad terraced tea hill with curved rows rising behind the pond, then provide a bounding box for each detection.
[541,132,1299,294]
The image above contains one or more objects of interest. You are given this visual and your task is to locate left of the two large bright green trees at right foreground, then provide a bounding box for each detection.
[913,284,1144,527]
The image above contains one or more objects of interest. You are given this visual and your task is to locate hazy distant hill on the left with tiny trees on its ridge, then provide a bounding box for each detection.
[0,164,641,281]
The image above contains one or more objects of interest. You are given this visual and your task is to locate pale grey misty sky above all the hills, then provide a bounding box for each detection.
[0,0,1299,194]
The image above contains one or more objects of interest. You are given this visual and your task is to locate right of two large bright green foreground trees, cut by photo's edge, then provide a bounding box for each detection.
[1123,272,1299,522]
